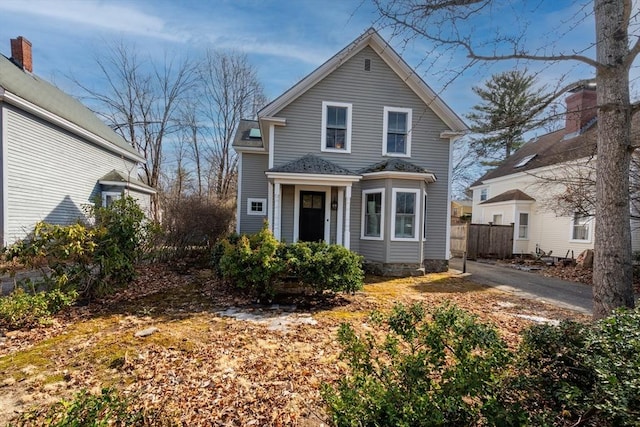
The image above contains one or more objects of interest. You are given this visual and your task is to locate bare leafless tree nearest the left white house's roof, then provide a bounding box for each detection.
[75,42,194,219]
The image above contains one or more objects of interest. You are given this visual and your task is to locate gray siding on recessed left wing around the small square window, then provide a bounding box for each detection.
[240,153,269,233]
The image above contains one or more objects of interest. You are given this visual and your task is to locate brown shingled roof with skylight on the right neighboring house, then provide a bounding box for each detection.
[471,122,597,188]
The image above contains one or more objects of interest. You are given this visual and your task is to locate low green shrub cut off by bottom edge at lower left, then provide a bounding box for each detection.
[14,388,149,427]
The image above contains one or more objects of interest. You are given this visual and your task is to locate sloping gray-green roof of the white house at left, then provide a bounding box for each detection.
[0,55,144,161]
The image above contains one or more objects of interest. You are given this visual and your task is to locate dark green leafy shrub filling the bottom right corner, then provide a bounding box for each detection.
[509,309,640,426]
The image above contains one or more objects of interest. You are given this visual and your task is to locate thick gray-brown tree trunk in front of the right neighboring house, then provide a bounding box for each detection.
[593,0,634,318]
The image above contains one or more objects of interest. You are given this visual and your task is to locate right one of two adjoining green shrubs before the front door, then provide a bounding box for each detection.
[283,242,364,292]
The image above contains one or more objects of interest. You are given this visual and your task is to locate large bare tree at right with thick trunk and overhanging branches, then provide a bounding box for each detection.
[374,0,640,317]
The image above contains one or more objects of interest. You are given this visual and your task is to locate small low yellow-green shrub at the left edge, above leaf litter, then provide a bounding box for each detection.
[0,288,78,329]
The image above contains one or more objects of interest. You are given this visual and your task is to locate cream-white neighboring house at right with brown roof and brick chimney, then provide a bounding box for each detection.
[470,87,638,257]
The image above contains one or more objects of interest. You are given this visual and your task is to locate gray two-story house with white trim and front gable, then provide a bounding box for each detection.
[234,29,467,275]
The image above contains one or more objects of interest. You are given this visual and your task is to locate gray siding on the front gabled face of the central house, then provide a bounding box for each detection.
[274,47,449,262]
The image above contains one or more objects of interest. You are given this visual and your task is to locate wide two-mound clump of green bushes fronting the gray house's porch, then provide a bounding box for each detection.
[212,227,364,296]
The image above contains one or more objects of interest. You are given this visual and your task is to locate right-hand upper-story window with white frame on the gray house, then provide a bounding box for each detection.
[382,107,412,157]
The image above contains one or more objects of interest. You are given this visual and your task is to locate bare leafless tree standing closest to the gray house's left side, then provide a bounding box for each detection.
[198,50,266,200]
